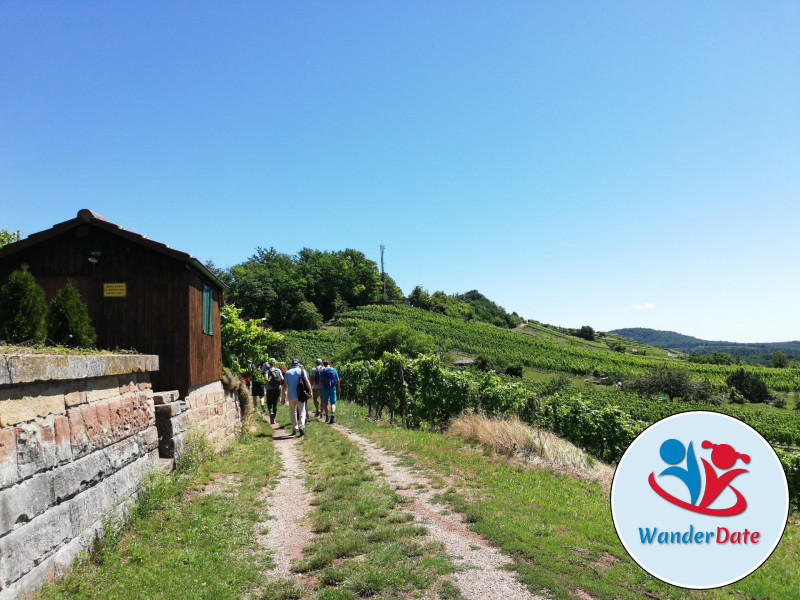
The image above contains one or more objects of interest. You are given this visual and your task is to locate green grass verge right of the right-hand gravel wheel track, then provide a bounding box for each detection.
[339,402,800,600]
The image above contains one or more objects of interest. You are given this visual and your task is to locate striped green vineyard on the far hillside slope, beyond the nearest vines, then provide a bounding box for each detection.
[337,306,800,392]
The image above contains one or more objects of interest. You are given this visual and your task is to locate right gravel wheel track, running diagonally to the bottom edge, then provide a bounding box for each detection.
[333,425,545,600]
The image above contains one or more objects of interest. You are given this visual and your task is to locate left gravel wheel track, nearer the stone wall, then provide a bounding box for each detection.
[256,418,313,584]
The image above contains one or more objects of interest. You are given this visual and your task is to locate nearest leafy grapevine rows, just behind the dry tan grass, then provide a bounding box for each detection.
[340,353,800,509]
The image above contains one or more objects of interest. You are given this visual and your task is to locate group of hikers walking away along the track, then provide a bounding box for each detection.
[250,358,341,437]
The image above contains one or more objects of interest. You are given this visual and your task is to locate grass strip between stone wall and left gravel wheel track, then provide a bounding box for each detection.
[31,425,279,600]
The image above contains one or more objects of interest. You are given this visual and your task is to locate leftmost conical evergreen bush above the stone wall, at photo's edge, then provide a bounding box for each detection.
[0,265,47,344]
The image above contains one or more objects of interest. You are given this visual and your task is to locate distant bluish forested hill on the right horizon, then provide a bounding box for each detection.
[610,327,800,365]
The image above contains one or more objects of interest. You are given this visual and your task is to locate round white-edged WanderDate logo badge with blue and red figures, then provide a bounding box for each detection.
[611,411,789,589]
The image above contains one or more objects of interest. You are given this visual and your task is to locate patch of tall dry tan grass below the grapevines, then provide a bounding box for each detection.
[447,413,614,486]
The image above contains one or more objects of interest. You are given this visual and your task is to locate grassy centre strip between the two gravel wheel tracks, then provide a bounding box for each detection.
[284,414,458,600]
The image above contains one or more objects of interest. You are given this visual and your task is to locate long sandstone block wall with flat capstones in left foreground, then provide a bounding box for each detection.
[0,355,159,600]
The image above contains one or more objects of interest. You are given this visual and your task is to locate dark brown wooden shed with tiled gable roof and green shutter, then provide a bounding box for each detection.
[0,209,225,397]
